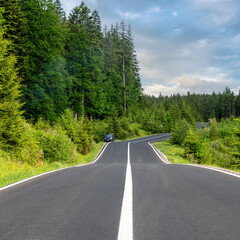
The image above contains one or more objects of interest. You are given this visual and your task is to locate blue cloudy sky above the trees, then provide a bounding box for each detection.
[61,0,240,96]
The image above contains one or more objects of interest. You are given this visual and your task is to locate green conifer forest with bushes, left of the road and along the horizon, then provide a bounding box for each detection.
[0,0,240,181]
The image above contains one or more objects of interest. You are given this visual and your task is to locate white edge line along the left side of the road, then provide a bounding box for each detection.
[0,143,109,191]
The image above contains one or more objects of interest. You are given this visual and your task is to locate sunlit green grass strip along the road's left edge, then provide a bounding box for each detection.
[0,142,103,187]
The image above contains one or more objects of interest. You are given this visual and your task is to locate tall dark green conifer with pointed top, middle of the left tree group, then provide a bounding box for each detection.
[66,3,106,118]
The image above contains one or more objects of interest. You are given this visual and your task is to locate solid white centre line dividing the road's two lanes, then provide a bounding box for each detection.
[118,142,133,240]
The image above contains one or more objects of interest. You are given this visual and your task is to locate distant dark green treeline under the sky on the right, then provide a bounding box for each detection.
[141,87,240,122]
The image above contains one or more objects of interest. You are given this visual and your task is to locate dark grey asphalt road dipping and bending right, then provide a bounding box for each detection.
[0,134,240,240]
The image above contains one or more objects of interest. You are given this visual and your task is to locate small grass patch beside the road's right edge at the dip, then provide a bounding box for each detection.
[154,140,190,164]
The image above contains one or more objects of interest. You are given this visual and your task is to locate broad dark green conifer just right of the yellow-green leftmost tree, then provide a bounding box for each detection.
[20,0,67,120]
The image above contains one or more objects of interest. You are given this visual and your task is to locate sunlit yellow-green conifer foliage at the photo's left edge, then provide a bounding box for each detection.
[0,10,42,165]
